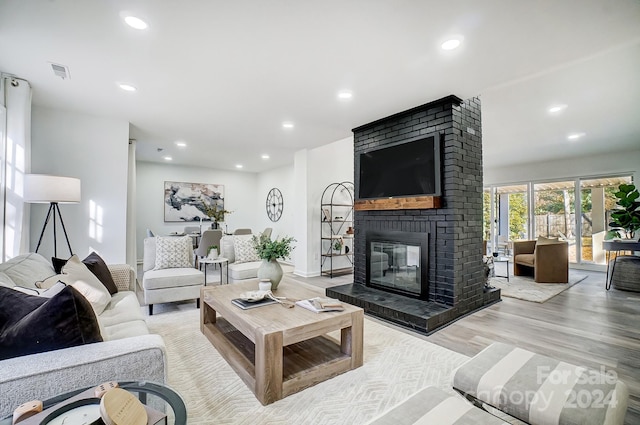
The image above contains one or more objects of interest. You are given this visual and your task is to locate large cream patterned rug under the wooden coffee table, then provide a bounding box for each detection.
[147,303,467,425]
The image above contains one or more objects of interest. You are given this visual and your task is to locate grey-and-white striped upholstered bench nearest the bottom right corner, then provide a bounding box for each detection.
[453,343,629,425]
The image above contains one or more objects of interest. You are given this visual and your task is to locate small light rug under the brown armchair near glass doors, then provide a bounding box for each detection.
[490,271,587,303]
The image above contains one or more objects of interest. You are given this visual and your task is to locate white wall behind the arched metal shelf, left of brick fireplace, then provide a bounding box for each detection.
[295,137,354,277]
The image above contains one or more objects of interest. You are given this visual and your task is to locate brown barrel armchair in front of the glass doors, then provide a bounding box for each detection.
[513,236,569,283]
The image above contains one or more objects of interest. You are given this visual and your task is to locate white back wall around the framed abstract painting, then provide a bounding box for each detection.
[136,161,260,260]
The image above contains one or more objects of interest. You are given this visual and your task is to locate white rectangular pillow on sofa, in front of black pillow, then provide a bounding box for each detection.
[62,255,111,315]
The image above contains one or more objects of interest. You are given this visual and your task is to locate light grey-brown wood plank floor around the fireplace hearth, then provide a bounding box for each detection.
[289,271,640,425]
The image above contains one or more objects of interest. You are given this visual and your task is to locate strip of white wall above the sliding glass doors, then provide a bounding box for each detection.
[483,150,640,186]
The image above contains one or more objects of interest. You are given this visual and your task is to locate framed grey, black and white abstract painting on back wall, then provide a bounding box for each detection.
[164,181,224,222]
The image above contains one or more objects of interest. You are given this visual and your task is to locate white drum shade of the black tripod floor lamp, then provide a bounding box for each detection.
[24,174,80,204]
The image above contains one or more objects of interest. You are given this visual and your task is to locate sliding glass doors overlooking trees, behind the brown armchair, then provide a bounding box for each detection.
[483,175,633,265]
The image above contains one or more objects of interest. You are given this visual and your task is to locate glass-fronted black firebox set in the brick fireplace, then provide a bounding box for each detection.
[365,230,429,300]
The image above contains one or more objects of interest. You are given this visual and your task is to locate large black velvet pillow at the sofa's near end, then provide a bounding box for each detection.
[0,286,102,360]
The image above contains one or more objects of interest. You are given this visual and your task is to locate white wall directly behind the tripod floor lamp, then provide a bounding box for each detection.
[30,106,129,263]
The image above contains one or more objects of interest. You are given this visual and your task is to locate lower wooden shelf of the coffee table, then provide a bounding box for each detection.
[203,317,352,405]
